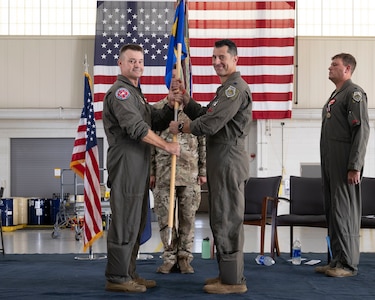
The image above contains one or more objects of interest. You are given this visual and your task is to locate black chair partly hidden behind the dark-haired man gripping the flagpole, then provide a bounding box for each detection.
[243,176,281,257]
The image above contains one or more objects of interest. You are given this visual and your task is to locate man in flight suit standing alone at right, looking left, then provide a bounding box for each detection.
[315,53,369,277]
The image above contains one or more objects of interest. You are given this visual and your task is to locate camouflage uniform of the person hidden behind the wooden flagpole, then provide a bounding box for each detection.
[150,99,206,265]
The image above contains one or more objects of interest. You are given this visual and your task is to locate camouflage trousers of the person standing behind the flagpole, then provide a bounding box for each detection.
[153,184,201,263]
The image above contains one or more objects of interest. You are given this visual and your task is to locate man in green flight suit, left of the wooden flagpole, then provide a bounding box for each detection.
[103,44,180,293]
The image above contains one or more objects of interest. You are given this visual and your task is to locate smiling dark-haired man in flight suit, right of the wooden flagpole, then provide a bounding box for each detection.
[169,40,251,294]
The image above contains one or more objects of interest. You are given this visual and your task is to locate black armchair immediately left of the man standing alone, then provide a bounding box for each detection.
[270,176,327,255]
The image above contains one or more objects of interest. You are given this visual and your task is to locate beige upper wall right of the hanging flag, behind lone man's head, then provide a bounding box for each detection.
[293,37,375,108]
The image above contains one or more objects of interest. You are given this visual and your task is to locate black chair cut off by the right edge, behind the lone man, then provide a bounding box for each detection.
[361,177,375,229]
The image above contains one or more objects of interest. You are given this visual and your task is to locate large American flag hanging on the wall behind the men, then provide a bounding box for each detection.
[94,0,295,119]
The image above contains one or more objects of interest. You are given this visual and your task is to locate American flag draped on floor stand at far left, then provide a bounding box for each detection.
[70,72,103,251]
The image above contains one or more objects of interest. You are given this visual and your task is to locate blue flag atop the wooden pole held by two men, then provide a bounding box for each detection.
[165,0,188,89]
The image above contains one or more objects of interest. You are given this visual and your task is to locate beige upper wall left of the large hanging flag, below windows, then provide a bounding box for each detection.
[0,37,94,108]
